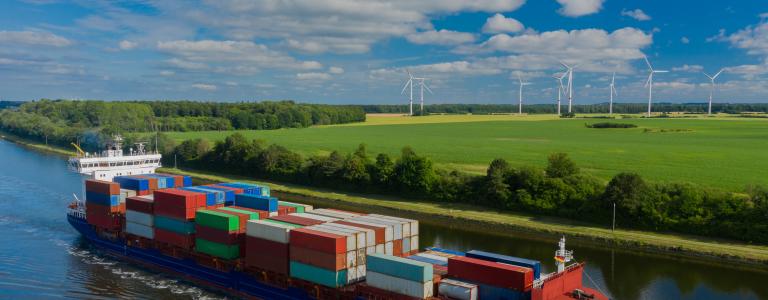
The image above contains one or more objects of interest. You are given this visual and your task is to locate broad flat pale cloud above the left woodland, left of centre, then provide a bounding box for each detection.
[157,40,323,75]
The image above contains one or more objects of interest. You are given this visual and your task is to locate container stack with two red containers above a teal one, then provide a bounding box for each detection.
[289,225,350,288]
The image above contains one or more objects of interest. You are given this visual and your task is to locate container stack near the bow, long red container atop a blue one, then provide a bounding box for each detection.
[448,256,533,300]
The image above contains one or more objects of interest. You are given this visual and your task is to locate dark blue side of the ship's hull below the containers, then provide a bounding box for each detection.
[67,215,312,300]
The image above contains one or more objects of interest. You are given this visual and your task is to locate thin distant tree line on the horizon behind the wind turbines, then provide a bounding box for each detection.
[361,103,768,115]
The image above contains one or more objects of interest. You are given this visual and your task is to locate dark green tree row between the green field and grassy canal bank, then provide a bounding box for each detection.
[170,134,768,243]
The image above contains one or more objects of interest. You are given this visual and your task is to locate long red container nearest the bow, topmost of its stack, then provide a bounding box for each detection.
[448,256,533,291]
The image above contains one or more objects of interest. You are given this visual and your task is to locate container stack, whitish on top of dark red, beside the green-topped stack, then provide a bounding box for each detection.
[244,220,302,275]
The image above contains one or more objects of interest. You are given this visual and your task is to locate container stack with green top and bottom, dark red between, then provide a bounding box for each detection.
[195,208,259,259]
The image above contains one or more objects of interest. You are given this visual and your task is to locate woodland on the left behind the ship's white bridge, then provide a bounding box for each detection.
[0,99,365,150]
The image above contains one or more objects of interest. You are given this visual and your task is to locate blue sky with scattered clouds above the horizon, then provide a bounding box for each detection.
[0,0,768,104]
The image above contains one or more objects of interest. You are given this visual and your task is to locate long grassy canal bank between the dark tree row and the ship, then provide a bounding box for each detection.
[161,169,768,268]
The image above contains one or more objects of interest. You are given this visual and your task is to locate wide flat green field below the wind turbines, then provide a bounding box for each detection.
[170,115,768,190]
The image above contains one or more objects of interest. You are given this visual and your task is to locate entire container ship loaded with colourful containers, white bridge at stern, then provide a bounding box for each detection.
[67,136,607,300]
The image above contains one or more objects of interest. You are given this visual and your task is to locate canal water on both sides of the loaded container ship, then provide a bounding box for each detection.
[0,140,768,299]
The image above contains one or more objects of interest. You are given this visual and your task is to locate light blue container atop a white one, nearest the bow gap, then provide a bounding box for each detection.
[365,253,433,282]
